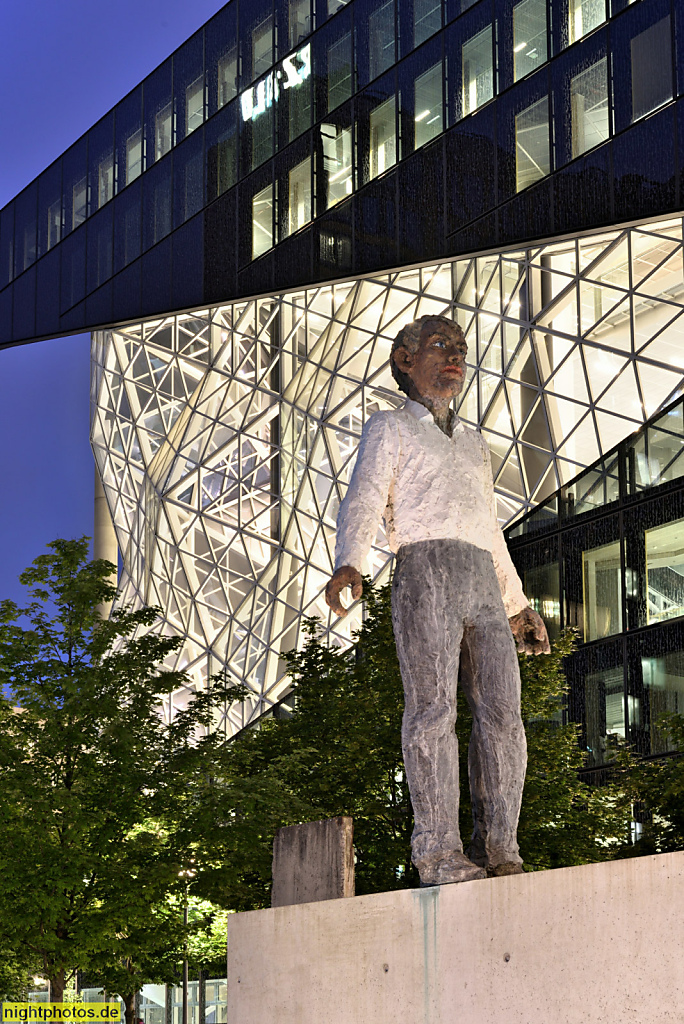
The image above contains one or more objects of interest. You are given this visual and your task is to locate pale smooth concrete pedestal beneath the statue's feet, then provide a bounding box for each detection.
[227,853,684,1024]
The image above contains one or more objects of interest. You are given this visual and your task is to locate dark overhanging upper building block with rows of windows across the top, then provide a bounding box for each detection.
[0,0,684,345]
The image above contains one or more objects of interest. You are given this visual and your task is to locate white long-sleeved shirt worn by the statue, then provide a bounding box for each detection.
[335,399,528,616]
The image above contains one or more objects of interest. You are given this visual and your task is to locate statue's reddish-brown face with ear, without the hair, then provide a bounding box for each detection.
[393,321,468,406]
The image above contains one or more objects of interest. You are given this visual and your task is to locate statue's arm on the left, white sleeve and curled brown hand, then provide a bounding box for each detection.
[326,414,396,615]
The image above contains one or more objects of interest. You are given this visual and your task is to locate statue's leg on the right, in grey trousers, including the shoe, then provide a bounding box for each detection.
[461,553,527,874]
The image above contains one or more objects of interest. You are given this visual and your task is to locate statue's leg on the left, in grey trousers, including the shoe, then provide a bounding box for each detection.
[392,541,482,885]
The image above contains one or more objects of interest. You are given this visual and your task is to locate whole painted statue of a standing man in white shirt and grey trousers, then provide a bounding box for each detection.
[326,316,549,885]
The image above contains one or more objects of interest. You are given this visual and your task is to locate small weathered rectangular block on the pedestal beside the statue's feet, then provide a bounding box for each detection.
[270,817,354,906]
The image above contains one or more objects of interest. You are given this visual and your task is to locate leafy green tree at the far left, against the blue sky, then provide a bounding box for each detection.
[0,538,238,1024]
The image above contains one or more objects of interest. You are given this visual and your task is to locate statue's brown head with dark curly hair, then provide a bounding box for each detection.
[390,314,468,406]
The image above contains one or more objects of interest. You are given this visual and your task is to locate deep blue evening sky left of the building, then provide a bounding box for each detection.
[0,0,223,601]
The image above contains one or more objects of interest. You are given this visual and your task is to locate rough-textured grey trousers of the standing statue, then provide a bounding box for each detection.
[392,541,527,868]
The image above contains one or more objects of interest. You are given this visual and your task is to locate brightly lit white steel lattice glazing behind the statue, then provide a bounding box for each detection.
[92,218,684,734]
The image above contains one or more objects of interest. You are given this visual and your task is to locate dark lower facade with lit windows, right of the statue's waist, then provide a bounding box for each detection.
[508,389,684,767]
